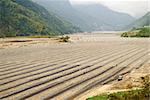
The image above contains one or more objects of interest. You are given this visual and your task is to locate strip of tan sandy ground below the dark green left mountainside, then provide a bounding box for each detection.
[0,38,59,49]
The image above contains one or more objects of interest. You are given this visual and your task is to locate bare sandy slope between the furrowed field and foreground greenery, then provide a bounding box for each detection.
[74,63,150,100]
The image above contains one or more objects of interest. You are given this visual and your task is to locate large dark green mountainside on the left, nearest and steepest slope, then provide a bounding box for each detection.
[0,0,80,36]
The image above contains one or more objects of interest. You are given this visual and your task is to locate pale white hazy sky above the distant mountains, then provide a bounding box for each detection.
[70,0,150,17]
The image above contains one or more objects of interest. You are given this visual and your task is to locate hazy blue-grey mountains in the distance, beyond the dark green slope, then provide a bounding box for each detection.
[34,0,134,31]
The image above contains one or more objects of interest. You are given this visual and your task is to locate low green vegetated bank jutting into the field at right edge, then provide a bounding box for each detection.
[121,27,150,37]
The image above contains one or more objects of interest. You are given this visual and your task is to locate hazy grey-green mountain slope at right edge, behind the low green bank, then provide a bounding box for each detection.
[126,12,150,29]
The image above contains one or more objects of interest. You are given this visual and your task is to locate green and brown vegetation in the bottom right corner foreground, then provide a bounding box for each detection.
[87,76,150,100]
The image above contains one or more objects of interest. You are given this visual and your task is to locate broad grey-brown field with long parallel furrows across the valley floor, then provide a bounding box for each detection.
[0,33,150,100]
